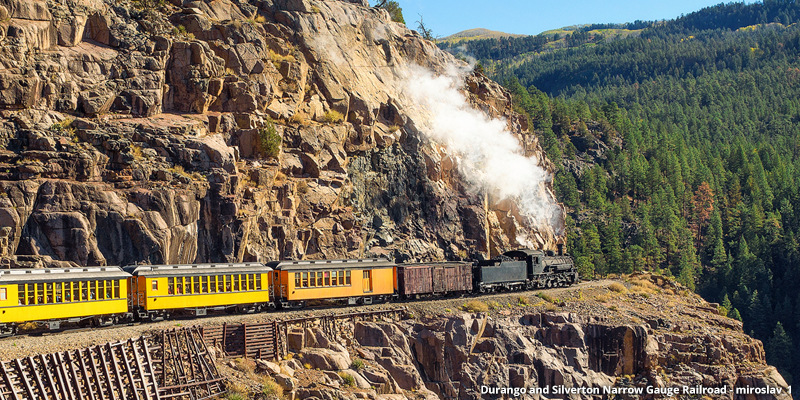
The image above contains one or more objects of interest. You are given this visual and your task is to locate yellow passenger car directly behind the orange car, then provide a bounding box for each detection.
[124,263,272,320]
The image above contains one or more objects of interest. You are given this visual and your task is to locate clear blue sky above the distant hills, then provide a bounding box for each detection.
[394,0,753,36]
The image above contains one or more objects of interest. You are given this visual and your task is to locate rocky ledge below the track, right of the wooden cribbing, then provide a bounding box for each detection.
[220,275,792,400]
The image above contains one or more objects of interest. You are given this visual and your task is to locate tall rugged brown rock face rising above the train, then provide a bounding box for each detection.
[0,0,558,266]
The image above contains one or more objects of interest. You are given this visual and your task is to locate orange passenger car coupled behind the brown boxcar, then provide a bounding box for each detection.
[269,258,397,308]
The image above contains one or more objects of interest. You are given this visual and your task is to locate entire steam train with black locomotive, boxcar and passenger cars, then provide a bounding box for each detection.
[0,246,578,336]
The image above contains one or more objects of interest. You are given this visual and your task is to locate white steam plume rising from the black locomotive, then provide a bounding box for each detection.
[404,66,563,236]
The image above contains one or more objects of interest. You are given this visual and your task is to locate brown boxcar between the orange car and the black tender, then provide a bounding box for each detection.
[397,262,472,297]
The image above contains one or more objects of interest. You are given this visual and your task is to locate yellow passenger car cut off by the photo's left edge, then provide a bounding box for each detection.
[0,267,130,335]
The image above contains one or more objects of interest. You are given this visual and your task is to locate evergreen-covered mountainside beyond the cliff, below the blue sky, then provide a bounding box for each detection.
[440,0,800,384]
